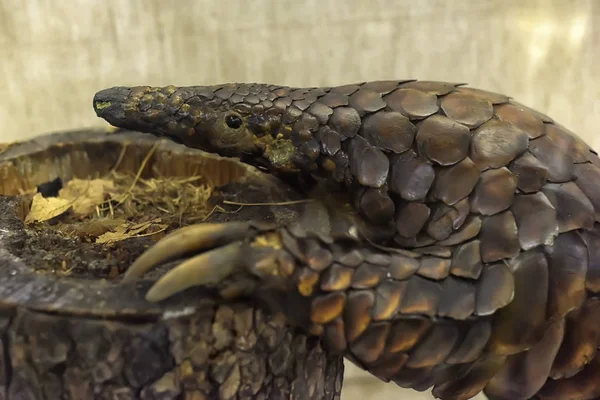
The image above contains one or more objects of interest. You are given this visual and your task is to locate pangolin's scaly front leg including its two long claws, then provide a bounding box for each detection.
[128,217,514,399]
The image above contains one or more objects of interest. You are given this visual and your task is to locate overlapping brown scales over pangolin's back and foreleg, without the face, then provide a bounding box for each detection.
[243,80,600,400]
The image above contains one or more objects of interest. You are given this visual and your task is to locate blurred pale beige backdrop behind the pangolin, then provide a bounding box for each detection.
[0,0,600,400]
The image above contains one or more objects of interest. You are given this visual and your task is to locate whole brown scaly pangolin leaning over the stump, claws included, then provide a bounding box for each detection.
[94,81,600,400]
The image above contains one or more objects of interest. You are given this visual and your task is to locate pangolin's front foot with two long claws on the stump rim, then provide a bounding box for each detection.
[123,222,289,302]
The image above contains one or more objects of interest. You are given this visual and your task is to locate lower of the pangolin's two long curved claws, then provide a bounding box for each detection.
[146,242,243,302]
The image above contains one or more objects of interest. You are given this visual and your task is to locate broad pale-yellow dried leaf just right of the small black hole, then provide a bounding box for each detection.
[58,179,115,217]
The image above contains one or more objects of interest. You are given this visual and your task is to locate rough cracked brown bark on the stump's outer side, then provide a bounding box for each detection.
[0,302,343,400]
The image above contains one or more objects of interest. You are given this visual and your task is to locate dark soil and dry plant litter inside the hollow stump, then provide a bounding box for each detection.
[4,170,228,279]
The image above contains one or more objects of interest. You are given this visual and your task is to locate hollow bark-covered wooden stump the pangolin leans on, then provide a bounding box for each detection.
[0,130,343,400]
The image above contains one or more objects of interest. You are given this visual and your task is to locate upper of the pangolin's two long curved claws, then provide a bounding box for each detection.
[123,222,251,282]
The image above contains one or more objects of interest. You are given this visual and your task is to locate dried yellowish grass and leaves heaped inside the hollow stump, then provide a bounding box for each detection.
[25,146,220,244]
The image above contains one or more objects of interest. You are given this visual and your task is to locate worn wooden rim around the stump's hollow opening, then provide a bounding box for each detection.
[0,129,281,320]
